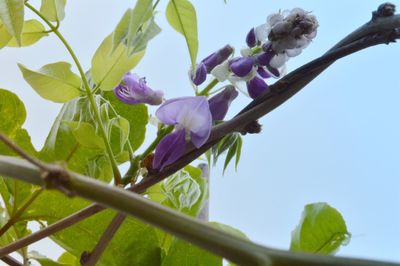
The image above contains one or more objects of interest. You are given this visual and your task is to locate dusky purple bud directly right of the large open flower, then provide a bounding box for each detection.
[208,85,239,121]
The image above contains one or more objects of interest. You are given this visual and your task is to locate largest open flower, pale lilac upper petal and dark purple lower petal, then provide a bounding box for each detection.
[153,96,212,170]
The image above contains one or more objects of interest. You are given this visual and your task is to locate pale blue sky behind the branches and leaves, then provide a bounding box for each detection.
[0,0,400,262]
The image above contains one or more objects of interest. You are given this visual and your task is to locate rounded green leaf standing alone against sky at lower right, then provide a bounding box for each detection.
[290,202,351,254]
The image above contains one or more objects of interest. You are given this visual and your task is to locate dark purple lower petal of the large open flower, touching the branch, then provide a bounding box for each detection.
[153,129,186,171]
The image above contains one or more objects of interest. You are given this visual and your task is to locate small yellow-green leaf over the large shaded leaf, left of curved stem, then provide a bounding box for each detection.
[65,121,105,150]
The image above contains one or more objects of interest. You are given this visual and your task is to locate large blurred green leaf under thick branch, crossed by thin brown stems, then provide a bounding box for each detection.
[26,191,161,266]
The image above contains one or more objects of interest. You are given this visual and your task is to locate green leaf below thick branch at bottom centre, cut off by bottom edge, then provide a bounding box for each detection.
[162,238,222,266]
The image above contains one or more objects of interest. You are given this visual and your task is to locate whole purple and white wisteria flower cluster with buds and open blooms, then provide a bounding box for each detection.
[114,8,318,170]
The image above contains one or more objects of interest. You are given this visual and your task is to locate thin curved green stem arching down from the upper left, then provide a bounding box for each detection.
[25,3,122,185]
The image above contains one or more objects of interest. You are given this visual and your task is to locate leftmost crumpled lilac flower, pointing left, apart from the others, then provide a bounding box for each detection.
[114,72,164,105]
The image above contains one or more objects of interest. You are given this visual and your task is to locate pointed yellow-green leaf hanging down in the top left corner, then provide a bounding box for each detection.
[0,0,24,45]
